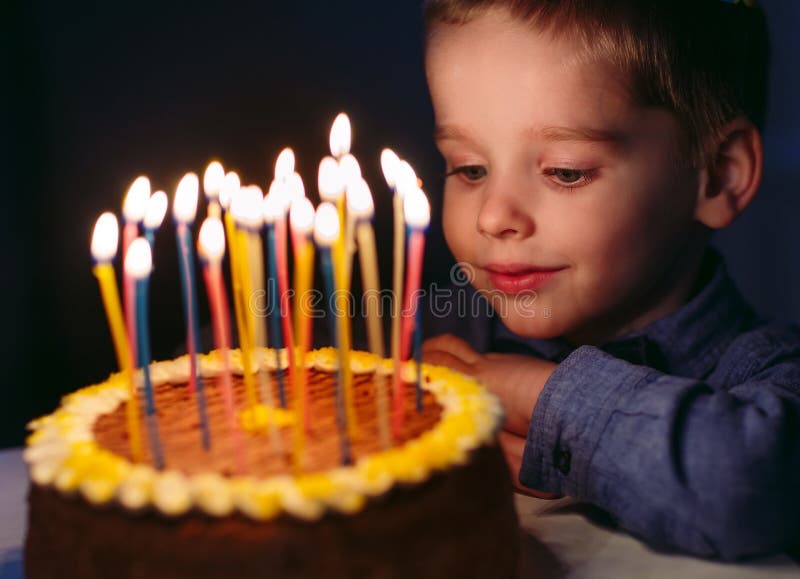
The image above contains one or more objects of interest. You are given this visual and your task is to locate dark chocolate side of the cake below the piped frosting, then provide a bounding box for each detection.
[25,445,518,579]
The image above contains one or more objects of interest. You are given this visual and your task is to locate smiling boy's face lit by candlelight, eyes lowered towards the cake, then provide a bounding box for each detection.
[426,12,703,343]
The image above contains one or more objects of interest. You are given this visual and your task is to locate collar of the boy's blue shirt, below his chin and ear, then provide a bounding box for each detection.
[492,249,756,378]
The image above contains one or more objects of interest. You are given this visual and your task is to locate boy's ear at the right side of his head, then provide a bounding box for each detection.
[695,118,764,229]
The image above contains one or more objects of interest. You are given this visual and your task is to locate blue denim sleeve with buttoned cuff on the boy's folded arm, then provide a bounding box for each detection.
[520,330,800,560]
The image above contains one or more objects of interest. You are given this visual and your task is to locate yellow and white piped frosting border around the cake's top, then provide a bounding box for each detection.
[24,349,502,520]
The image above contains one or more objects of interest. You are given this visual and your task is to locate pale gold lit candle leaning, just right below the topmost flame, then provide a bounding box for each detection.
[347,179,391,448]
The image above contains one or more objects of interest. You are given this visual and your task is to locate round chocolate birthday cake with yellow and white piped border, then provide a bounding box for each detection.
[25,349,518,579]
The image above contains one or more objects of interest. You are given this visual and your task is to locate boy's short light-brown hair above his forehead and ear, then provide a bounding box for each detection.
[425,0,769,165]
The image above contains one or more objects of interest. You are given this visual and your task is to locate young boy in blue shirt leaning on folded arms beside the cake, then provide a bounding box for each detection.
[424,0,800,560]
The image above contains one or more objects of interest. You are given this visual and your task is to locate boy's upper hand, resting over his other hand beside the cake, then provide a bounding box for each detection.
[422,334,556,436]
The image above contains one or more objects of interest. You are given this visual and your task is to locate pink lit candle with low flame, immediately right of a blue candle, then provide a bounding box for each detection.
[197,217,245,472]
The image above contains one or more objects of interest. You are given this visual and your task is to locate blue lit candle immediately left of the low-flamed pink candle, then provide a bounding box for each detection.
[172,173,211,450]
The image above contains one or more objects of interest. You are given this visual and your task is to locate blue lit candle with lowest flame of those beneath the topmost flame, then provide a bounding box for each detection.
[314,202,353,464]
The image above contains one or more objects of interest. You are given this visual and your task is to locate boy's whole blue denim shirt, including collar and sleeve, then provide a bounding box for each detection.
[426,251,800,560]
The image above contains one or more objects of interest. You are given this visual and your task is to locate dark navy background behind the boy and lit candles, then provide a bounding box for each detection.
[0,0,800,447]
